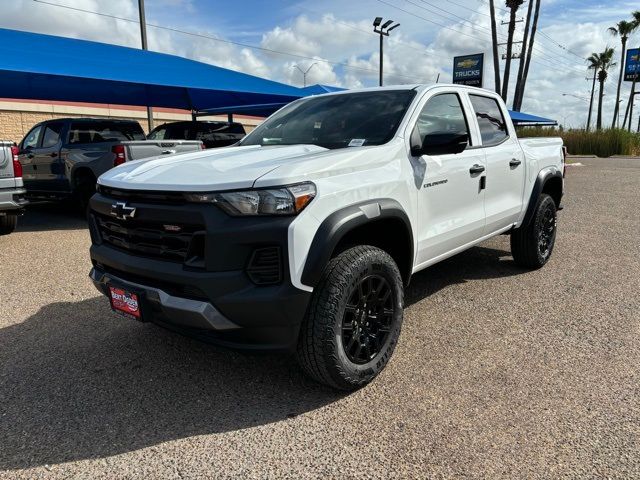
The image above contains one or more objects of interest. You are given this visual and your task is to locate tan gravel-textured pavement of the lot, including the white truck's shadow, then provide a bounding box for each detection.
[0,159,640,479]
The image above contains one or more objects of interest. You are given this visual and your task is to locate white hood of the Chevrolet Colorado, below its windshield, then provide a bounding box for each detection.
[98,145,327,192]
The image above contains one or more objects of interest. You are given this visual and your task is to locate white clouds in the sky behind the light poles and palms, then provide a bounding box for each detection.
[0,0,638,126]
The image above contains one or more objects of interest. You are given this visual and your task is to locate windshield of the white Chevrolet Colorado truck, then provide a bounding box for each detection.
[240,90,416,149]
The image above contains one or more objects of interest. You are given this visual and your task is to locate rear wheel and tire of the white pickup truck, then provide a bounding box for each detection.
[511,193,558,270]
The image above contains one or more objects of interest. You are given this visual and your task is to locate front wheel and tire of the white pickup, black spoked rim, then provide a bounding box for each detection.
[297,246,404,390]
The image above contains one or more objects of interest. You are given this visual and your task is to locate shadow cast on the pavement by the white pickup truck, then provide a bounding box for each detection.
[0,244,518,470]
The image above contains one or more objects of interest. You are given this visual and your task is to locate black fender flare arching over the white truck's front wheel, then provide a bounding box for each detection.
[301,198,414,287]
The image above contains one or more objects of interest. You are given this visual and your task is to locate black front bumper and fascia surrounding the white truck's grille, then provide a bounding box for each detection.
[89,189,310,351]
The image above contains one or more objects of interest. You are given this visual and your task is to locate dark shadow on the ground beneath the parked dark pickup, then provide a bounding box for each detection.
[16,202,88,232]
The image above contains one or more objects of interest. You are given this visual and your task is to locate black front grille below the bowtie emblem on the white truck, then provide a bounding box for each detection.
[95,214,204,262]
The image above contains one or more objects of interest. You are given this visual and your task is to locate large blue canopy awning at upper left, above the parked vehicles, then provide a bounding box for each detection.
[0,29,304,110]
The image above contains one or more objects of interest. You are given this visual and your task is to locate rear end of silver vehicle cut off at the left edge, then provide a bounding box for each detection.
[0,140,27,235]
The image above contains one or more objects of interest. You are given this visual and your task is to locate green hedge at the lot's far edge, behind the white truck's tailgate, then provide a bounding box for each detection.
[518,128,640,157]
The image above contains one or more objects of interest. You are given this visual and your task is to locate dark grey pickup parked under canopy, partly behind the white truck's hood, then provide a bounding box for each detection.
[18,118,203,204]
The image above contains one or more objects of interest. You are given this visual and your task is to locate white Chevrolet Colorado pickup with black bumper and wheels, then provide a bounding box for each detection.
[90,85,564,390]
